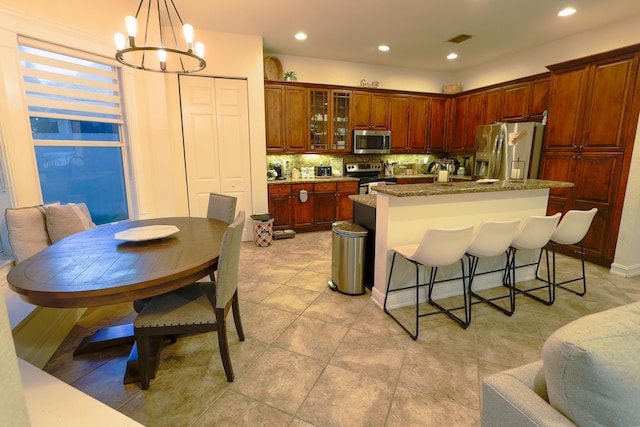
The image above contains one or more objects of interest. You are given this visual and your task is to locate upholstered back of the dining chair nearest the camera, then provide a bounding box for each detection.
[216,211,245,308]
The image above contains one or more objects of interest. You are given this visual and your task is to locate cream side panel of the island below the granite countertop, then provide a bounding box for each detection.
[372,188,549,308]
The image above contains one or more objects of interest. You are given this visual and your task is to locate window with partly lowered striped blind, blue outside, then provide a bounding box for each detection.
[20,41,129,224]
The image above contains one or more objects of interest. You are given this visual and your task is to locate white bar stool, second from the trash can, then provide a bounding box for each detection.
[467,218,520,322]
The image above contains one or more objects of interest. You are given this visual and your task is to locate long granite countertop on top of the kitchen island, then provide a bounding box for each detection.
[376,179,574,197]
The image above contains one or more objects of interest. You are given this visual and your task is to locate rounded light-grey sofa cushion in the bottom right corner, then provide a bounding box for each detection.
[542,303,640,426]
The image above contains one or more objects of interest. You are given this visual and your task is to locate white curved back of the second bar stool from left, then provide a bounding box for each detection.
[467,218,520,257]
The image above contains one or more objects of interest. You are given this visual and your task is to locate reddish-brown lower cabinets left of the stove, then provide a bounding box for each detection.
[268,181,358,232]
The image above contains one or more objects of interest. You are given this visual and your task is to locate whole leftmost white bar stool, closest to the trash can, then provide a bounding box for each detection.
[384,225,473,340]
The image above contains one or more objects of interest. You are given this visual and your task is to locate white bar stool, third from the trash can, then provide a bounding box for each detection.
[507,212,561,305]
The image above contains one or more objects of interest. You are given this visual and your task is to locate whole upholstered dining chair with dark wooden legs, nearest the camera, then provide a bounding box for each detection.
[134,211,245,390]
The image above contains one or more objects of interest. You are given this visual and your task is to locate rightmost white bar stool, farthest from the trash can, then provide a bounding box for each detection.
[536,208,598,296]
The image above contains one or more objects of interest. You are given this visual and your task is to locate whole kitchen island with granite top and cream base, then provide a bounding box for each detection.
[350,179,573,308]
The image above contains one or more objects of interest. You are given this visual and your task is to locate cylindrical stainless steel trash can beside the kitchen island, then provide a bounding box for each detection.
[329,221,367,295]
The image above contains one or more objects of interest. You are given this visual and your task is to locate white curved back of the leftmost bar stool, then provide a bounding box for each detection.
[411,224,473,267]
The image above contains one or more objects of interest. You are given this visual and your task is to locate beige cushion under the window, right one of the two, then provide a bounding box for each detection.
[45,203,95,243]
